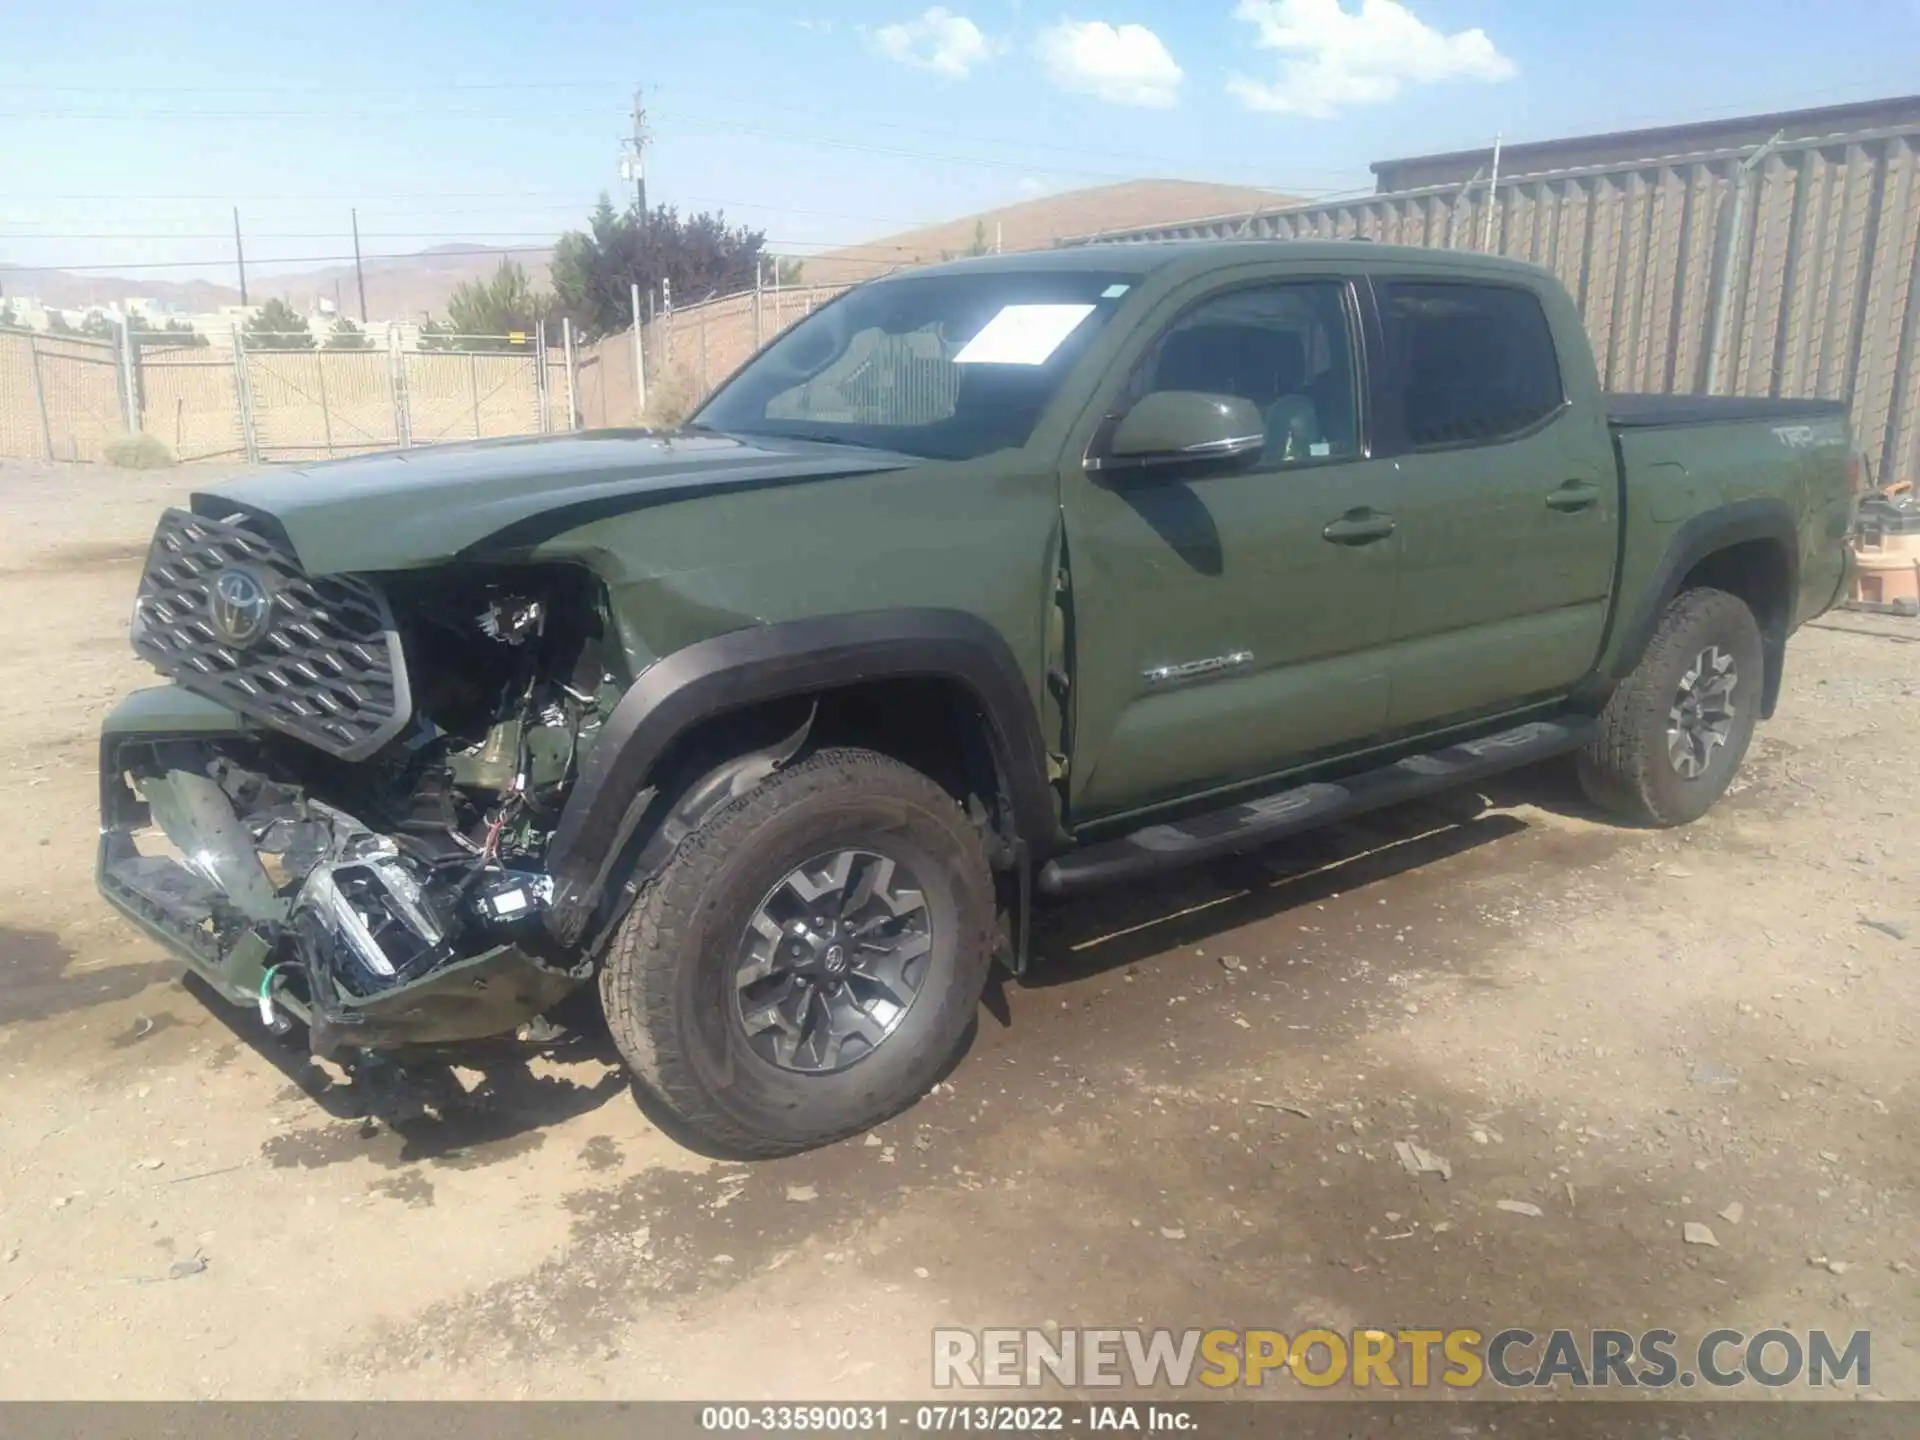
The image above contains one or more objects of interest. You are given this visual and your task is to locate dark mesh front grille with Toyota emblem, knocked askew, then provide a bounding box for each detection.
[132,511,411,760]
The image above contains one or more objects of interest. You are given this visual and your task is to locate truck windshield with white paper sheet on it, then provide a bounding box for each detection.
[693,271,1133,461]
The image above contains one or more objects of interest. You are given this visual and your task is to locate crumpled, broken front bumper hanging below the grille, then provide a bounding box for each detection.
[96,685,584,1054]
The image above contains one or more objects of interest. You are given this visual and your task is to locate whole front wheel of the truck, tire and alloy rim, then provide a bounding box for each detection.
[601,749,995,1158]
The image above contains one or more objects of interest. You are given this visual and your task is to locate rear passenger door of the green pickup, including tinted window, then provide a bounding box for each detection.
[1375,273,1619,732]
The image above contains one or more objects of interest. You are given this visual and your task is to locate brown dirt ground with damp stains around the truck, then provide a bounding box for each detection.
[0,465,1920,1398]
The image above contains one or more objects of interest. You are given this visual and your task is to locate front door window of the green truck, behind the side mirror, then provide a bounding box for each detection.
[1127,280,1359,474]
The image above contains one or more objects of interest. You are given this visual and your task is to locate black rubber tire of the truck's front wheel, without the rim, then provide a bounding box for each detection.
[601,749,995,1158]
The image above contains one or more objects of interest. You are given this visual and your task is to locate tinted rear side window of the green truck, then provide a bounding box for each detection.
[1377,280,1565,449]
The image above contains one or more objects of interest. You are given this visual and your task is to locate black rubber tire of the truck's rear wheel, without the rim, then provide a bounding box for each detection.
[1578,588,1764,828]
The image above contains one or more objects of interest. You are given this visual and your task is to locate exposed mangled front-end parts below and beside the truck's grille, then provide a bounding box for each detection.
[104,566,620,1048]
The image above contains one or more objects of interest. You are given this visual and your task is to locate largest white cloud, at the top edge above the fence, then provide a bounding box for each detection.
[1227,0,1521,119]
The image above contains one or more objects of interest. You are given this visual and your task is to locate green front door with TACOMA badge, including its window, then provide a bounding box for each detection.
[1062,278,1400,820]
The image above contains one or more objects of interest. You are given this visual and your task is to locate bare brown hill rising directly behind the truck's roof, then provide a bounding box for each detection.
[803,180,1298,284]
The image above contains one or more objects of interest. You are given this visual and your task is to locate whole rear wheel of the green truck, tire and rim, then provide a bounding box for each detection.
[1578,589,1764,826]
